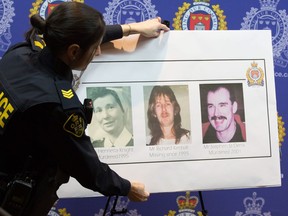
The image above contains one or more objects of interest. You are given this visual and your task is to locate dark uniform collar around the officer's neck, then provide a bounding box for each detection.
[39,47,73,83]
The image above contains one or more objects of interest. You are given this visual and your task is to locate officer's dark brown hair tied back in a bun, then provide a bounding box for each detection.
[26,2,105,55]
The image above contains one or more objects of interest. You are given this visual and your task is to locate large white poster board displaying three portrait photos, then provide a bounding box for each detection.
[59,30,281,197]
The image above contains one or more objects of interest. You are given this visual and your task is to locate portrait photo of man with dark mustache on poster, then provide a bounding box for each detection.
[200,83,246,143]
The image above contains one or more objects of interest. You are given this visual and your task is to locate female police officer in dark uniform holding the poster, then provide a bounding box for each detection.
[0,2,169,216]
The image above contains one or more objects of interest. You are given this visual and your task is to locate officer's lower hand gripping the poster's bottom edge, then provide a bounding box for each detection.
[128,182,150,202]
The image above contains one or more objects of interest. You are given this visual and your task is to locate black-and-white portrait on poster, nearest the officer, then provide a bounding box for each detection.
[90,87,133,148]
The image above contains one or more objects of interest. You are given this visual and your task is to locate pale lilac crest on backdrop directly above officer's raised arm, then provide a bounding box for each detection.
[103,0,158,24]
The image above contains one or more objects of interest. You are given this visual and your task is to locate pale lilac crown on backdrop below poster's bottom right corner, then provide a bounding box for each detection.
[235,192,271,216]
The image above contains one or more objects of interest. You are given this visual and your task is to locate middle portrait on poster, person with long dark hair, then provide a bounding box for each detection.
[144,85,191,145]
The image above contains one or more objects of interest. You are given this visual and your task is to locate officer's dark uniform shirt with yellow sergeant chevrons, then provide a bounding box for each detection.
[0,25,130,215]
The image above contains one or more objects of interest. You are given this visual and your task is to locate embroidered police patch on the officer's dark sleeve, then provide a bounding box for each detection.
[63,114,85,137]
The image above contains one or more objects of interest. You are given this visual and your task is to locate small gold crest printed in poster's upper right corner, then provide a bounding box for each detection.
[246,62,264,87]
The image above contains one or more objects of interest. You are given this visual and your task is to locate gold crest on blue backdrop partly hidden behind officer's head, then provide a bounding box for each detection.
[29,0,84,19]
